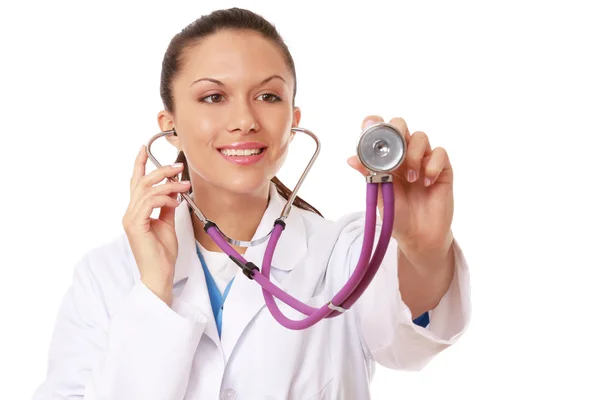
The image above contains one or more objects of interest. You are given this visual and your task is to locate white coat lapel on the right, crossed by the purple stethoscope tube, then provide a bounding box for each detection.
[221,185,307,360]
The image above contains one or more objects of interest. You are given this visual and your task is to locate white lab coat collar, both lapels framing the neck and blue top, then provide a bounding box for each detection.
[173,184,308,354]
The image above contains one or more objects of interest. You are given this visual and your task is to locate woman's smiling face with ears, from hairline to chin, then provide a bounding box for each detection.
[159,30,300,194]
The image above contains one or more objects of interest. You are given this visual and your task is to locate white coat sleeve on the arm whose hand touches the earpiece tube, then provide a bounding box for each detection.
[33,252,204,400]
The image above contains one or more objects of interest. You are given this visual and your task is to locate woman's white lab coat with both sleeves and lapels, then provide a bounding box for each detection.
[34,186,471,400]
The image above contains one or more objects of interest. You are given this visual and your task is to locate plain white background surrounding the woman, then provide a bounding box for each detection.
[0,0,600,400]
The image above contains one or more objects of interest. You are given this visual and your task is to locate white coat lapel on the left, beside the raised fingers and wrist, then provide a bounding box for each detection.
[172,201,220,346]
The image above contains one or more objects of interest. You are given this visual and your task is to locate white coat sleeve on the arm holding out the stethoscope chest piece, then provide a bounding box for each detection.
[338,219,471,371]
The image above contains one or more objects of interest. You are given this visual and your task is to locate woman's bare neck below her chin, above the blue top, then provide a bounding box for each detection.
[192,183,270,254]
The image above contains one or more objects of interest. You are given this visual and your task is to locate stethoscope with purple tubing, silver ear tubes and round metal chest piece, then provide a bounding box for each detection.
[147,122,406,330]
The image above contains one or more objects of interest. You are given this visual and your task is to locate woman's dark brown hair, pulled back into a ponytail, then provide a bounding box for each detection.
[160,8,322,216]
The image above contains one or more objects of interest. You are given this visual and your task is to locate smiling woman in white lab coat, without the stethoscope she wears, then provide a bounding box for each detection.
[35,9,470,400]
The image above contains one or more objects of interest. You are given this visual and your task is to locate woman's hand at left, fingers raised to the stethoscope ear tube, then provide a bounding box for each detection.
[122,146,190,307]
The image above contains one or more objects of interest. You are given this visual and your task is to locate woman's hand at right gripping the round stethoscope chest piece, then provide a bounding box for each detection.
[348,116,454,266]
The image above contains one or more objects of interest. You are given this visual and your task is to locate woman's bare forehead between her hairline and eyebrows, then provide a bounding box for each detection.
[181,30,290,81]
